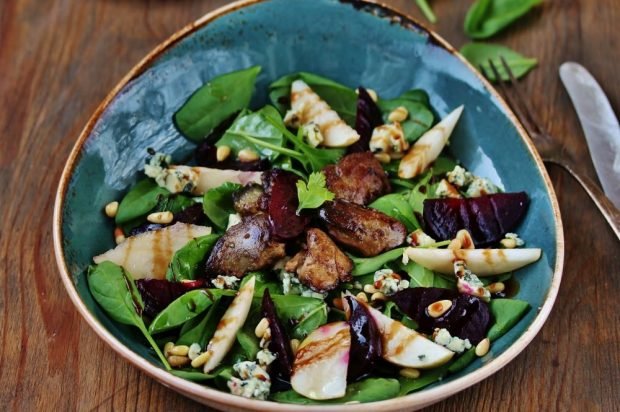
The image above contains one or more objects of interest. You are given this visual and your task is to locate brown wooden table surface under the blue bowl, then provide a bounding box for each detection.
[0,0,620,411]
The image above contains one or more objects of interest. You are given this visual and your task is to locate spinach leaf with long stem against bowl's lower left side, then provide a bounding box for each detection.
[87,261,170,370]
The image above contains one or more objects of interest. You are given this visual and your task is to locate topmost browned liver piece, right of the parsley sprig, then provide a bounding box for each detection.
[323,152,391,205]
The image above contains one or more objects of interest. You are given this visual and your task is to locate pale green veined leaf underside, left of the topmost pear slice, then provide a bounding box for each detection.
[215,106,283,161]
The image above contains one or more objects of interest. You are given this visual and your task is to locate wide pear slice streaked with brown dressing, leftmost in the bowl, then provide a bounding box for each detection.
[93,222,211,279]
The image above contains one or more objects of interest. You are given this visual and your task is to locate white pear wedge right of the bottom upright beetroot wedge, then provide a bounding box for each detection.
[358,301,454,369]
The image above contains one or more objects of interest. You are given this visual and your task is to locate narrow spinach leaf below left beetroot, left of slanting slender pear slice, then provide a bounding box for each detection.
[149,289,234,334]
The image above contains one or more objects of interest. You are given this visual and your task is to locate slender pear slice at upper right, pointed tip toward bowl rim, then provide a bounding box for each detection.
[398,105,463,179]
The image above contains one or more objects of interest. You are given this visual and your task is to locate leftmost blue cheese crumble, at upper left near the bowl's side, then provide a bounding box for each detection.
[144,152,198,193]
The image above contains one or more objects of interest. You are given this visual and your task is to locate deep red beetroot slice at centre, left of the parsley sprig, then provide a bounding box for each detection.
[266,169,310,239]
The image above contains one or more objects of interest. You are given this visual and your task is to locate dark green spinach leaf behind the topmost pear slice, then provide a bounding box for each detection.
[269,72,357,126]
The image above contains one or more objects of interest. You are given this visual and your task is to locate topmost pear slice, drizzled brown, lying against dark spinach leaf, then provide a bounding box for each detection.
[291,80,360,147]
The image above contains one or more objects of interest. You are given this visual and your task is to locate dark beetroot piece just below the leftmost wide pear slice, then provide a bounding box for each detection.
[136,279,205,318]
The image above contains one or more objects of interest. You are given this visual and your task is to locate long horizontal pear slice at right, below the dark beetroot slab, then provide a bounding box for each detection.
[405,247,541,276]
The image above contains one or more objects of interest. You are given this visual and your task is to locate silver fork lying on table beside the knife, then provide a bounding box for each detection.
[480,57,620,239]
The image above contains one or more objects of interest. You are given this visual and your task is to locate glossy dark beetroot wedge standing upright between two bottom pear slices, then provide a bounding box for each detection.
[345,296,383,382]
